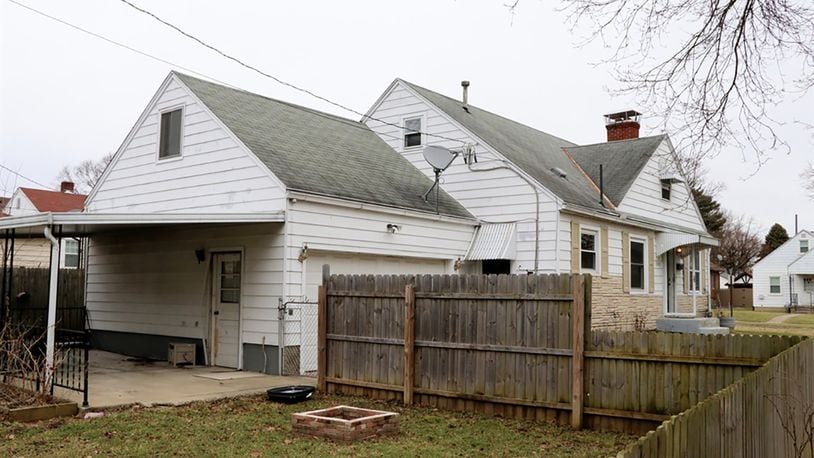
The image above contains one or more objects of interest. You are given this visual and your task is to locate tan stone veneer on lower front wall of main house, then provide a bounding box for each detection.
[591,276,707,331]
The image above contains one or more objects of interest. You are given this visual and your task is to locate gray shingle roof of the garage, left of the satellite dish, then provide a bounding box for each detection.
[175,72,472,218]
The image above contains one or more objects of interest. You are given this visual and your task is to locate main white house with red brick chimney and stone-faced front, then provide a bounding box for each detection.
[363,79,717,329]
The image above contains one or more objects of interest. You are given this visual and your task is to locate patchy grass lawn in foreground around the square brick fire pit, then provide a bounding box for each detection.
[0,396,635,457]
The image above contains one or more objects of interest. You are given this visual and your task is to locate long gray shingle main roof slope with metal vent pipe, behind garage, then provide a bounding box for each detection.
[400,80,604,210]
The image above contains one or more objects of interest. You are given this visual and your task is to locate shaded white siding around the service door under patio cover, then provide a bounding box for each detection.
[87,224,283,345]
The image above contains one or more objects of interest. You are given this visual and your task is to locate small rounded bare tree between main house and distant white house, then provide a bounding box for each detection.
[715,216,762,316]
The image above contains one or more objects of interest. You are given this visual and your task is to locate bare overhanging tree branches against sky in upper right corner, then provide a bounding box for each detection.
[556,0,814,163]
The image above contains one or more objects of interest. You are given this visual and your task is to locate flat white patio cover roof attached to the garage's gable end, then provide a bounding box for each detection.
[0,211,285,237]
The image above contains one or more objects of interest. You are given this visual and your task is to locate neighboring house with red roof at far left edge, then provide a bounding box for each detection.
[0,181,85,269]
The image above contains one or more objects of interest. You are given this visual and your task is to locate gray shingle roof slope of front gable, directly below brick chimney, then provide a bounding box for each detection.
[566,134,667,205]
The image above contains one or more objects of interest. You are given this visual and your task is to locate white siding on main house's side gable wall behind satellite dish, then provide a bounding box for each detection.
[365,84,570,273]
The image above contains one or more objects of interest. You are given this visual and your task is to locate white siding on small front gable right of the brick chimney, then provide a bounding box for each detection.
[618,141,706,231]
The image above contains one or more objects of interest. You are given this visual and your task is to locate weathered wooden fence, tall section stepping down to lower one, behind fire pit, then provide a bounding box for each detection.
[317,266,800,433]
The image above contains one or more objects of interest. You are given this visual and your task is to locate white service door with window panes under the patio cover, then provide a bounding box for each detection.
[212,253,241,368]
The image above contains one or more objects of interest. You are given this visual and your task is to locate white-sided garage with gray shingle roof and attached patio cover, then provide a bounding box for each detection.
[0,72,478,373]
